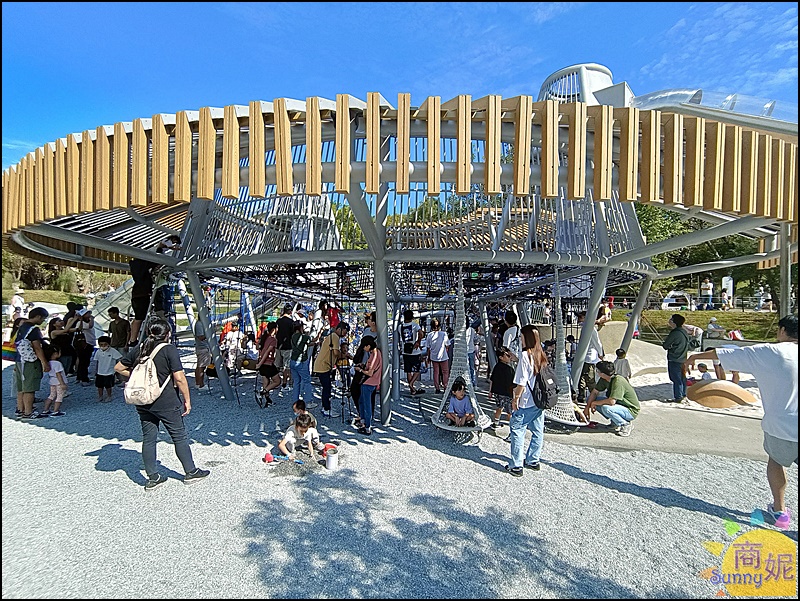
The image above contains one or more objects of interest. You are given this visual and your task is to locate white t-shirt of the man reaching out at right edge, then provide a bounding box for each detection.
[717,342,798,442]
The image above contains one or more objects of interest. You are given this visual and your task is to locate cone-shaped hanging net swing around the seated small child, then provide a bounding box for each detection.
[431,268,492,433]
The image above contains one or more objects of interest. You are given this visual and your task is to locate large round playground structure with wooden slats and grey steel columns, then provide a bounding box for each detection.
[2,64,797,423]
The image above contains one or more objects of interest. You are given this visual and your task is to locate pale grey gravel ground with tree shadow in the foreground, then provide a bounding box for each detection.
[2,351,798,598]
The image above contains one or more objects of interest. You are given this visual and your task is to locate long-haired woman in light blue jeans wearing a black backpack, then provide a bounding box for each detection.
[505,325,547,477]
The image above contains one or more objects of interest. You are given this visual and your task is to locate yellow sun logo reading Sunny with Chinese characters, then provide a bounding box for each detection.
[700,520,797,599]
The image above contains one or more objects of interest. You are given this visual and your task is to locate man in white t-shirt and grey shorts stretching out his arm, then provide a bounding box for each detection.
[686,315,798,528]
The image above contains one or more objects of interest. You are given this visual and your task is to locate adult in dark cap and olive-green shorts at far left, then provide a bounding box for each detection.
[14,307,50,419]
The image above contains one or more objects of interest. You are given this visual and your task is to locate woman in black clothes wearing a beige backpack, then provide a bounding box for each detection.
[114,318,211,490]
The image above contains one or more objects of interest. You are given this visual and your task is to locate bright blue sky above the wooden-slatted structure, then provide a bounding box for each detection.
[2,2,798,169]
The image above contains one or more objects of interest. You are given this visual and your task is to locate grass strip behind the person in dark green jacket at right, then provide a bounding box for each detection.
[612,309,780,342]
